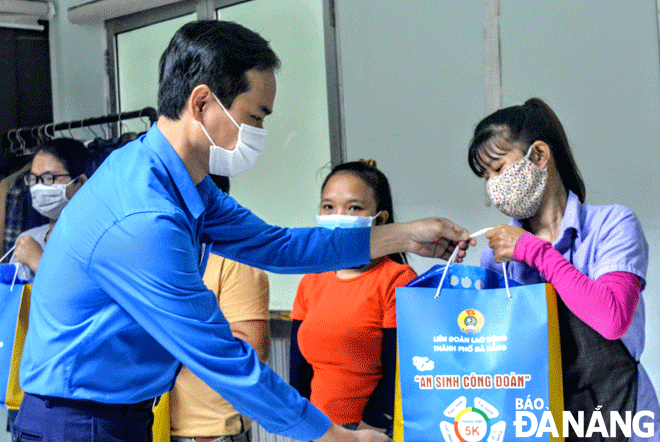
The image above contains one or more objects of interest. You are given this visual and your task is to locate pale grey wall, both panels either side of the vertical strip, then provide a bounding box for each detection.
[337,0,660,408]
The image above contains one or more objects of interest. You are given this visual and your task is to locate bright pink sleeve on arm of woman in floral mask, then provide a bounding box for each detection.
[513,232,641,339]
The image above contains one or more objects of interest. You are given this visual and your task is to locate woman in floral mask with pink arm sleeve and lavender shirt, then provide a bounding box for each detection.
[468,98,660,441]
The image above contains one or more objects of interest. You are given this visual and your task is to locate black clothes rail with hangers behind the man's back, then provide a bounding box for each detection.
[0,107,158,153]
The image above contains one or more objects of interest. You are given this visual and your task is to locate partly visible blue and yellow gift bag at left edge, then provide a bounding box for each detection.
[0,264,32,409]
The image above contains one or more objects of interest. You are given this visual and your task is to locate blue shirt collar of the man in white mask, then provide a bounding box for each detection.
[144,123,205,218]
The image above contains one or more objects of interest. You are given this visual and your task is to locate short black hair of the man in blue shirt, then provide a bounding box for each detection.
[158,20,280,120]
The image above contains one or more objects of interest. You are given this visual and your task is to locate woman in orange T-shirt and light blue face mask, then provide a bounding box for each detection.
[290,160,417,431]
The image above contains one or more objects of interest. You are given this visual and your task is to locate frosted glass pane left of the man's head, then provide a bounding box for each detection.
[117,14,197,132]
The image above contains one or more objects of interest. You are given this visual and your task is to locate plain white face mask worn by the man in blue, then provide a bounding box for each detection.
[199,94,268,177]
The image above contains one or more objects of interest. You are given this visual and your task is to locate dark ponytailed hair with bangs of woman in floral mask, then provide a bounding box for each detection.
[468,98,587,203]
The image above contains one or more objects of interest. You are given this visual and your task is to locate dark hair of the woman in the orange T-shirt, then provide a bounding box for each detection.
[321,160,408,264]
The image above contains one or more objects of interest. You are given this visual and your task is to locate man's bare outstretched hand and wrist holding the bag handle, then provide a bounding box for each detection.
[371,218,477,262]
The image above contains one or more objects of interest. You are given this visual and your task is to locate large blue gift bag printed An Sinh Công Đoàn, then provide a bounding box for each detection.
[394,264,563,442]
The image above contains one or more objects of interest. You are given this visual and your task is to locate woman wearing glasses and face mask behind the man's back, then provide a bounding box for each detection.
[10,138,90,280]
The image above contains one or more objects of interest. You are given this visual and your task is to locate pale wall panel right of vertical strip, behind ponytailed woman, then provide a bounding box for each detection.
[501,0,660,408]
